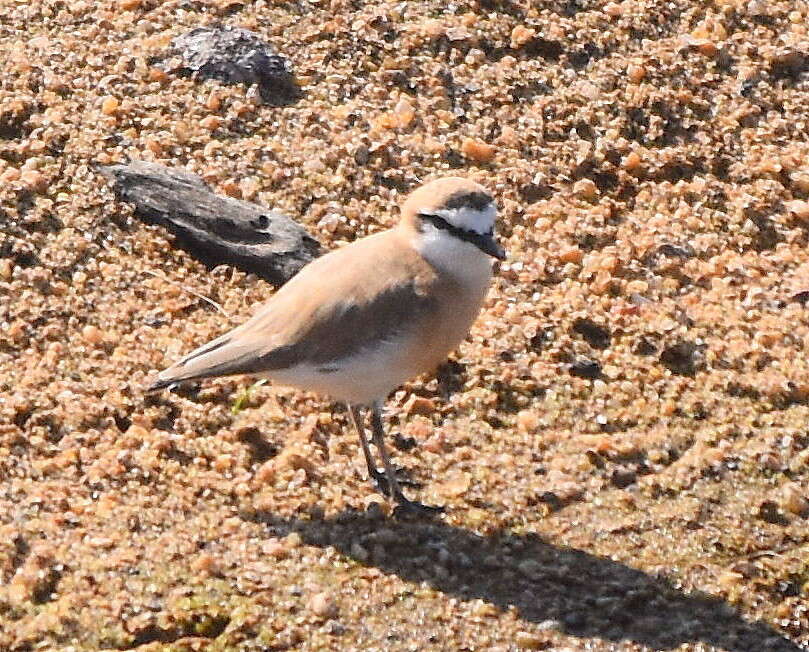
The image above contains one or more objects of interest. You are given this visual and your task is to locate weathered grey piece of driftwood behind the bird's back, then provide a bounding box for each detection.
[101,161,322,285]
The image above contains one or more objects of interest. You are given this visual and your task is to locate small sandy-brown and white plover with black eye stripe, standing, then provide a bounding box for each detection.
[147,177,498,513]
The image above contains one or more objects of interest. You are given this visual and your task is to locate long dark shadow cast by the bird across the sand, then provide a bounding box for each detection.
[243,510,801,652]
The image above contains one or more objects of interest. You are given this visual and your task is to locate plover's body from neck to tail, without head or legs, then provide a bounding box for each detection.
[153,229,489,403]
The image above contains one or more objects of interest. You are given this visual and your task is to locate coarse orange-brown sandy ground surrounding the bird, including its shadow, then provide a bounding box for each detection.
[0,0,809,652]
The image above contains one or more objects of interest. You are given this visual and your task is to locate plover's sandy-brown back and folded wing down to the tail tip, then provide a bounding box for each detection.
[149,232,439,390]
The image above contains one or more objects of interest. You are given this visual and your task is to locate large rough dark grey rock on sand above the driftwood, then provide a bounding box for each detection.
[162,25,300,106]
